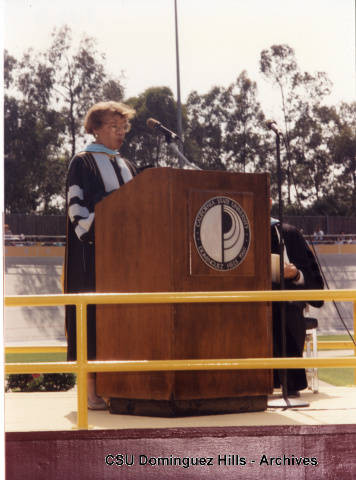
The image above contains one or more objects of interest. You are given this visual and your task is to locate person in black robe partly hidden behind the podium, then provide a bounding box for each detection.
[271,220,324,396]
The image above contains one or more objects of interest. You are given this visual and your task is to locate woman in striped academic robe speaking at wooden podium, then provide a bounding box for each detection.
[64,102,136,409]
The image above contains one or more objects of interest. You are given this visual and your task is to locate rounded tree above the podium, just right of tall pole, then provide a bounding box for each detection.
[186,71,270,172]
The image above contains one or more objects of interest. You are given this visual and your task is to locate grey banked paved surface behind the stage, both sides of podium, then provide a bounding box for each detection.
[4,248,356,345]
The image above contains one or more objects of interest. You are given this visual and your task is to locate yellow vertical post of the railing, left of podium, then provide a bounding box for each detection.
[76,300,88,430]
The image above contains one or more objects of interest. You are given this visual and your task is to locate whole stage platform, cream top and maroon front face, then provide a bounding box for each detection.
[5,383,356,480]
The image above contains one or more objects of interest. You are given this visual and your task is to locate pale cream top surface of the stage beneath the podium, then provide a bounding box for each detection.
[5,382,356,432]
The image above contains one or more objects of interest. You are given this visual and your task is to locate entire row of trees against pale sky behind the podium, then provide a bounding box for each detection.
[4,35,356,215]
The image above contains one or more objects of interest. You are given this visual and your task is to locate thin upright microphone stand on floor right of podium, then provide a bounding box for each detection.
[268,129,309,409]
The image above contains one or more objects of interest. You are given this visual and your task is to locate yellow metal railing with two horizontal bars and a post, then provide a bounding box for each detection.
[5,290,356,429]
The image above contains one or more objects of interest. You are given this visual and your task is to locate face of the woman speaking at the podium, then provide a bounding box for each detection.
[94,114,128,150]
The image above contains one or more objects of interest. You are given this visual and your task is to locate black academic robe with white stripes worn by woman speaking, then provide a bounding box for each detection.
[64,152,136,361]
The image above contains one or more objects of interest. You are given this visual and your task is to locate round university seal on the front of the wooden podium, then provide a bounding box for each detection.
[194,197,251,270]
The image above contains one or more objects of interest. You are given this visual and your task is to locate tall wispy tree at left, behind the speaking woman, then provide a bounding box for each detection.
[4,26,123,213]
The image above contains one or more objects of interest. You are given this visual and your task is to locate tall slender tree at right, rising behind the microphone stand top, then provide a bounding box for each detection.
[260,45,332,204]
